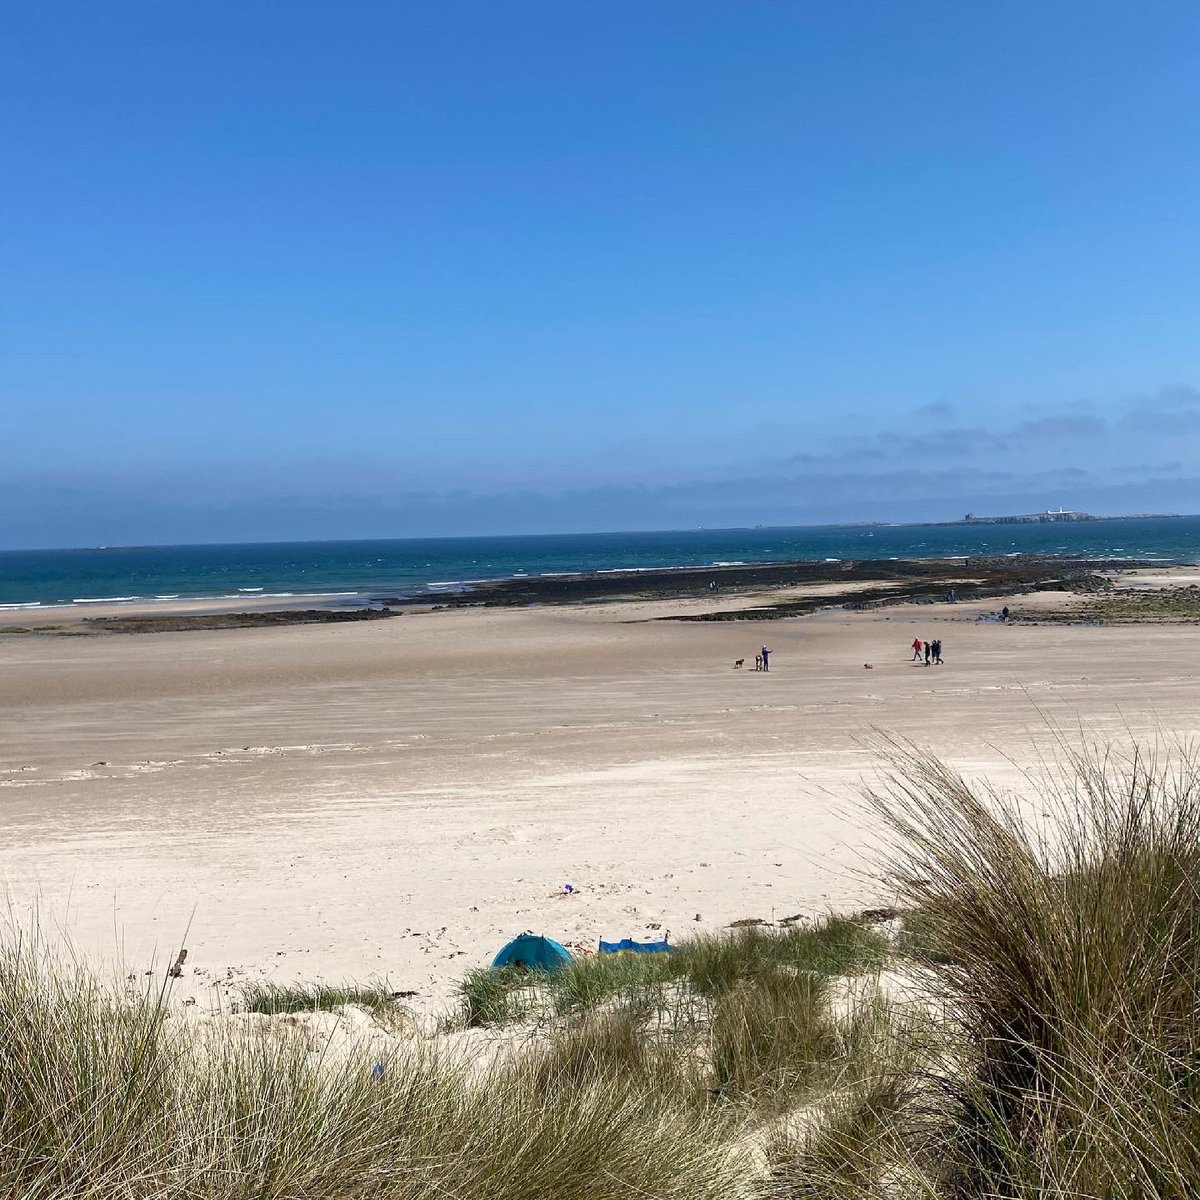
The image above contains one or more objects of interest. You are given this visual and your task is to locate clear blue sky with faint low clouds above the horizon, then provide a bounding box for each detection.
[0,0,1200,547]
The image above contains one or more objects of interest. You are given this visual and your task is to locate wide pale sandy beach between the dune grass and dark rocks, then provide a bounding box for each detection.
[0,570,1200,1008]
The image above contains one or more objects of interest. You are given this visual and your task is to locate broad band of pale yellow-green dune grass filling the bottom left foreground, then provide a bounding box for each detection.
[0,941,738,1200]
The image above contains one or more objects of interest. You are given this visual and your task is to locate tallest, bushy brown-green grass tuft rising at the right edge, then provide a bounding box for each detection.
[872,748,1200,1200]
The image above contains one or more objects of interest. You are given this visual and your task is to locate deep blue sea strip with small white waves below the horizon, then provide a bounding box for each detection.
[0,516,1200,610]
